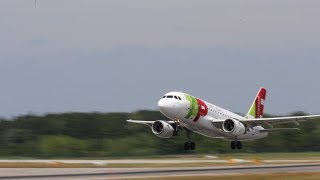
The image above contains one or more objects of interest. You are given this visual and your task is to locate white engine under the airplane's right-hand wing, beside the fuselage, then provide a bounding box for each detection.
[222,119,246,136]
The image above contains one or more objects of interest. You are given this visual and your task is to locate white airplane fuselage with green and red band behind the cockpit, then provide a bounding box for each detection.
[158,92,268,141]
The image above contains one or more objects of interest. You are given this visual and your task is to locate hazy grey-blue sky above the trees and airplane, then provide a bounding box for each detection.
[0,0,320,117]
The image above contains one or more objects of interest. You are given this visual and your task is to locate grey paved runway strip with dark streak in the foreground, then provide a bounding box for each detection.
[0,164,320,179]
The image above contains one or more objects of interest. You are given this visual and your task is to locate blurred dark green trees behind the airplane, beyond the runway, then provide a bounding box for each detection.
[0,111,320,158]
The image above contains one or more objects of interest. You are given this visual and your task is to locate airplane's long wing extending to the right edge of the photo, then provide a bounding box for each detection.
[242,115,320,128]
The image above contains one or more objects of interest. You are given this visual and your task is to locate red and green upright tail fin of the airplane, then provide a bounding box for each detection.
[245,88,267,119]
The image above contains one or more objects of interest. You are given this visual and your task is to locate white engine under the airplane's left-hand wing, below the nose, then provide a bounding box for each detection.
[152,120,174,138]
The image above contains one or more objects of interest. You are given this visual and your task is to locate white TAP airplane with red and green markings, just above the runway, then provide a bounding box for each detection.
[127,88,320,150]
